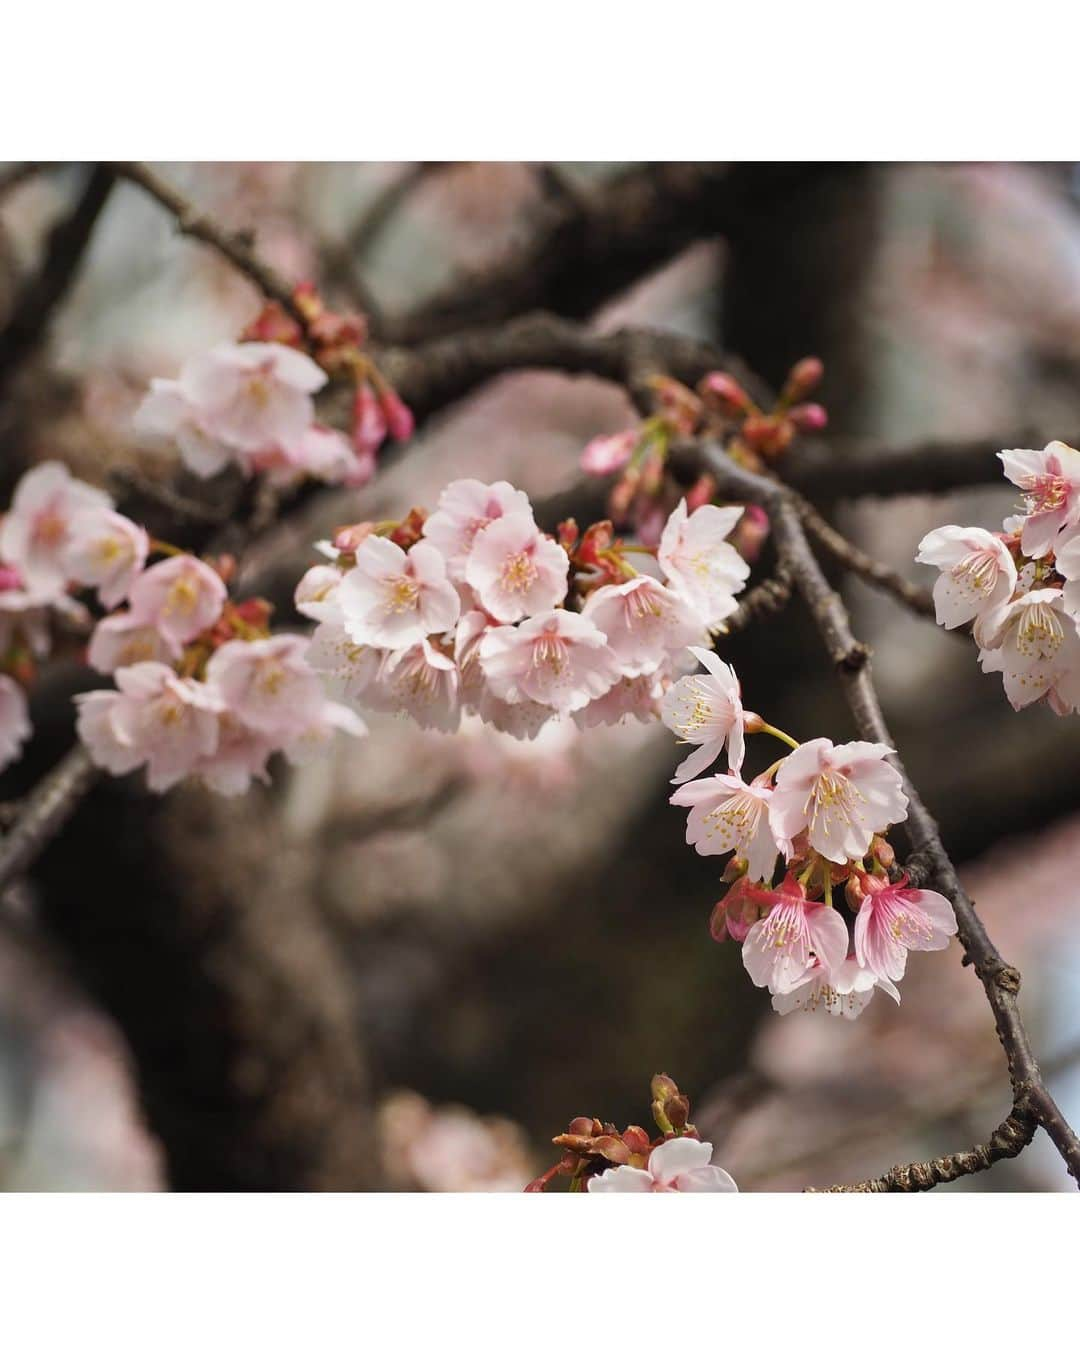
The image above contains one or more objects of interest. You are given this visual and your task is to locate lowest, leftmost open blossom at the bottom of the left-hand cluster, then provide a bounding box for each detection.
[76,662,221,792]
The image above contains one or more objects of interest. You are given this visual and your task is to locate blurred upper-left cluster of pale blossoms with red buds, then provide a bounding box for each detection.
[135,284,413,487]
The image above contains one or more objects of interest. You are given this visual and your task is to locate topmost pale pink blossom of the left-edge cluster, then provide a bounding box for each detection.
[0,460,112,590]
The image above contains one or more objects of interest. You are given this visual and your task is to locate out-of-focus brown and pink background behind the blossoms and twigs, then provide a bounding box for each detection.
[0,163,1080,1191]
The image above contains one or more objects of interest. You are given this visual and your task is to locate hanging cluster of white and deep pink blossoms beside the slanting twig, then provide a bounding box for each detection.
[662,649,956,1019]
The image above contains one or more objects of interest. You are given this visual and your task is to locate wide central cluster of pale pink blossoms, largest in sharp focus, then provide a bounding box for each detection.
[296,479,749,738]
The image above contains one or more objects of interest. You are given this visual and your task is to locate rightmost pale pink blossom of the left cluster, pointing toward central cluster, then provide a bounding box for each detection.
[207,633,324,745]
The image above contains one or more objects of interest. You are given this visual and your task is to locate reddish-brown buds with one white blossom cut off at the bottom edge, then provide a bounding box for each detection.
[525,1073,738,1193]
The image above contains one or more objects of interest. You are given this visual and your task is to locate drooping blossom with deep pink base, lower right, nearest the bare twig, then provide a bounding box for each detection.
[855,876,956,980]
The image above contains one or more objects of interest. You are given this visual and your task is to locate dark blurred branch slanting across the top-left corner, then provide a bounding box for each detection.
[0,165,113,387]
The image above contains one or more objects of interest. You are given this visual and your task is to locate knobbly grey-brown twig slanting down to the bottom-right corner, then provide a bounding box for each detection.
[702,446,1080,1184]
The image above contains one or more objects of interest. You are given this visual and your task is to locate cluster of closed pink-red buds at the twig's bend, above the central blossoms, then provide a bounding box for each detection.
[581,356,828,562]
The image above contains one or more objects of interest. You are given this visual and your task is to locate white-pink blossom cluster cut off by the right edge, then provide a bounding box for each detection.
[915,440,1080,716]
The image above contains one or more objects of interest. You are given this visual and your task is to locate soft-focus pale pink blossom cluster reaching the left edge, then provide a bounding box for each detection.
[0,462,363,794]
